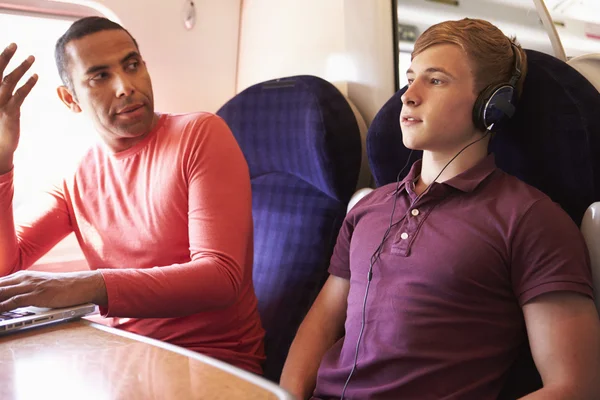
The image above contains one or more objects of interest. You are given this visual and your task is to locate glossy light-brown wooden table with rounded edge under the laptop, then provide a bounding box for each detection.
[0,320,293,400]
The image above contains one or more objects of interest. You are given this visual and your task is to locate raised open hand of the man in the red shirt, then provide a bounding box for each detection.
[0,43,38,174]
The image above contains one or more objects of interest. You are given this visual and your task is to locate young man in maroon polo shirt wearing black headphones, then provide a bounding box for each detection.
[281,19,600,400]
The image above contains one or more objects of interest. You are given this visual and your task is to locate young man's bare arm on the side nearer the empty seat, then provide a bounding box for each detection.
[280,275,350,399]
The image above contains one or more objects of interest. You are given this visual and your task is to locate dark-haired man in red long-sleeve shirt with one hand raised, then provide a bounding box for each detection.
[0,17,264,373]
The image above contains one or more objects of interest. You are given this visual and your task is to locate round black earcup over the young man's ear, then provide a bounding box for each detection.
[473,83,515,131]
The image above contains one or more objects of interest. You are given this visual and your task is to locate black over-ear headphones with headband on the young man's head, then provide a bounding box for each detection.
[473,40,521,131]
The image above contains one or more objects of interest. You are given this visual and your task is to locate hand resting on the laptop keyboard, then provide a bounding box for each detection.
[0,271,108,312]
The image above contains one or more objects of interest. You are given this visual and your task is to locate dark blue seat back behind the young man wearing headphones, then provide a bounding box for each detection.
[367,50,600,399]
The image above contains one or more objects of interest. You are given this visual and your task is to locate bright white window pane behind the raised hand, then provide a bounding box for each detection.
[0,5,102,209]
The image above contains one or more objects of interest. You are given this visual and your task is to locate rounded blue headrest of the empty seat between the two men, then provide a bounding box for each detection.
[217,75,361,203]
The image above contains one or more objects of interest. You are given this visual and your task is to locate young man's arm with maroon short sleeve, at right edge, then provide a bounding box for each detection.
[511,198,600,400]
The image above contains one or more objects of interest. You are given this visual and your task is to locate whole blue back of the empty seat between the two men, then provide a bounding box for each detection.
[217,76,361,382]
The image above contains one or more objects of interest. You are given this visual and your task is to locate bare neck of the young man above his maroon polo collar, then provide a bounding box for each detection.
[415,140,488,195]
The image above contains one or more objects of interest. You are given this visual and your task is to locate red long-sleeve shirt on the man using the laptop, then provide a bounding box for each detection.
[0,113,264,373]
